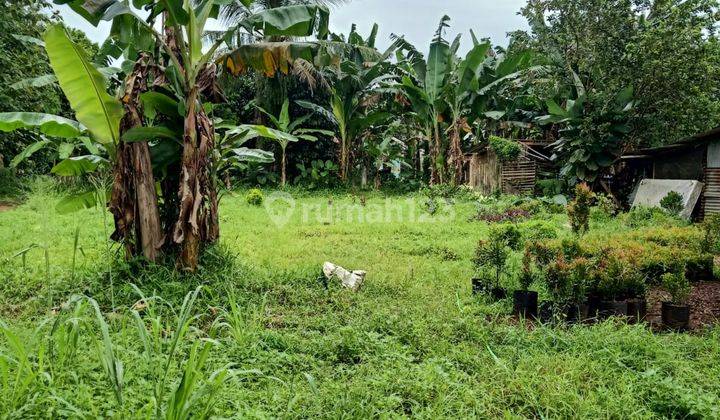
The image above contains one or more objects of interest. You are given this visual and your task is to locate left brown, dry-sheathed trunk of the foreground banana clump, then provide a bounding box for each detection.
[110,55,164,262]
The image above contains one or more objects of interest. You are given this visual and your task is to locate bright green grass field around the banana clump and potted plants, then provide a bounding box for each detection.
[0,185,720,418]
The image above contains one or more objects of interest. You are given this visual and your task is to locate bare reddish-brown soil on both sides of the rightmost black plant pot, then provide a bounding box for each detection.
[647,281,720,330]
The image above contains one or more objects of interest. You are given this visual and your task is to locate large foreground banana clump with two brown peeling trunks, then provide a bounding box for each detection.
[51,0,338,270]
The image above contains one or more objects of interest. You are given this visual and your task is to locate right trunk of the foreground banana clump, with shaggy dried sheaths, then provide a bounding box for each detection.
[173,86,220,271]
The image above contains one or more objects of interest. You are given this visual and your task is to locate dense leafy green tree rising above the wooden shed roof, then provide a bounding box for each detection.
[521,0,720,150]
